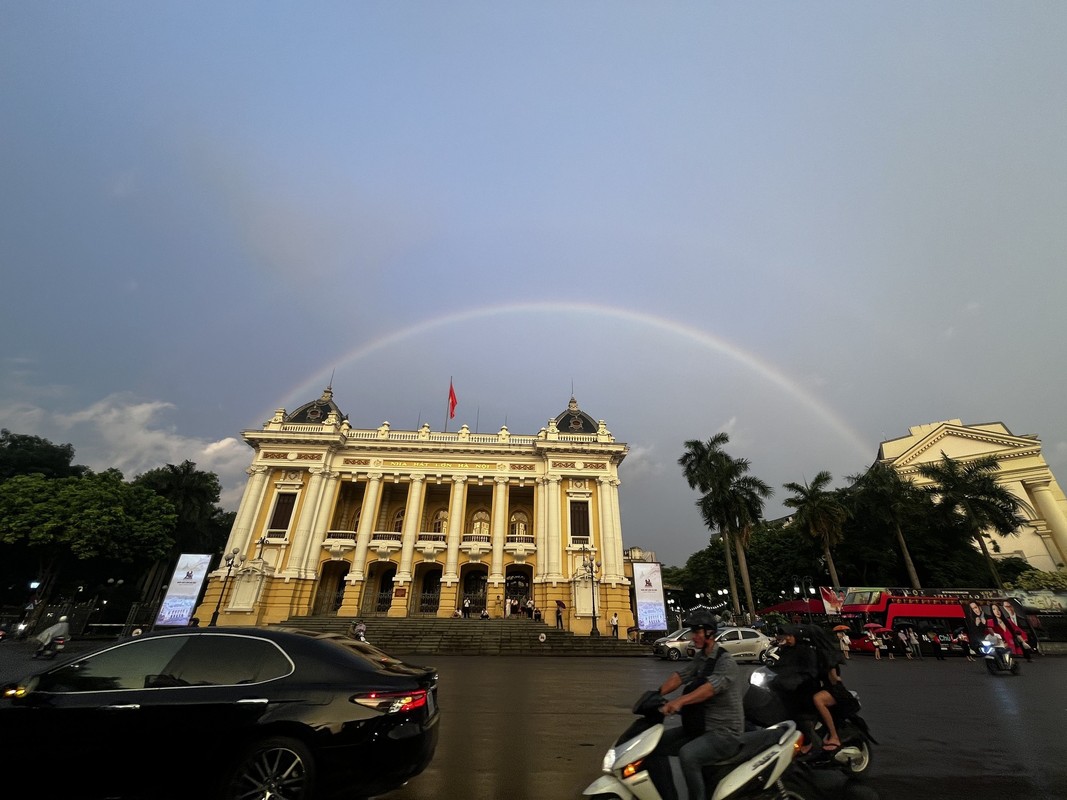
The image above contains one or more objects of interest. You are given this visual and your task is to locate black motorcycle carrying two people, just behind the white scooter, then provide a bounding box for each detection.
[744,667,878,775]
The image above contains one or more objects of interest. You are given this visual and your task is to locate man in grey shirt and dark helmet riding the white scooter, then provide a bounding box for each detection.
[653,612,745,800]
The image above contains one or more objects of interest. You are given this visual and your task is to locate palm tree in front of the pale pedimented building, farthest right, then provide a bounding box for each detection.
[919,450,1026,591]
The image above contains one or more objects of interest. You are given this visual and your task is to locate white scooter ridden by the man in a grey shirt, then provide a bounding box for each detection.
[582,691,805,800]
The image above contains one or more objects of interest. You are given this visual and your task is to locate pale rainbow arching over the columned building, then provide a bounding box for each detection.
[262,302,871,460]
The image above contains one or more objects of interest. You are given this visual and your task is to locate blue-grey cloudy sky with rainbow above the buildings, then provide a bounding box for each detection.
[0,0,1067,565]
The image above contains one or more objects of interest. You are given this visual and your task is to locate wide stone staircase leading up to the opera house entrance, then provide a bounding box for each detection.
[280,615,652,656]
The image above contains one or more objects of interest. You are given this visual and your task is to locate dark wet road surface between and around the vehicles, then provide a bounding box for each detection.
[0,641,1067,800]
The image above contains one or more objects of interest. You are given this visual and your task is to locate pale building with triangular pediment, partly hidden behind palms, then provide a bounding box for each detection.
[878,419,1067,572]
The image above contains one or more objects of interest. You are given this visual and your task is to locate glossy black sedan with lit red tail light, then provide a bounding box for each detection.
[0,627,440,800]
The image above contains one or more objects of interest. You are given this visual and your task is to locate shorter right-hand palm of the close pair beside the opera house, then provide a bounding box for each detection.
[699,457,770,614]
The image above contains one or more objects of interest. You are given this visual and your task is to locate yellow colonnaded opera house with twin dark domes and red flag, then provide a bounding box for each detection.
[197,388,633,634]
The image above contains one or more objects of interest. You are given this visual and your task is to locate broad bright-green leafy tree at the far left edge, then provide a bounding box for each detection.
[0,469,175,603]
